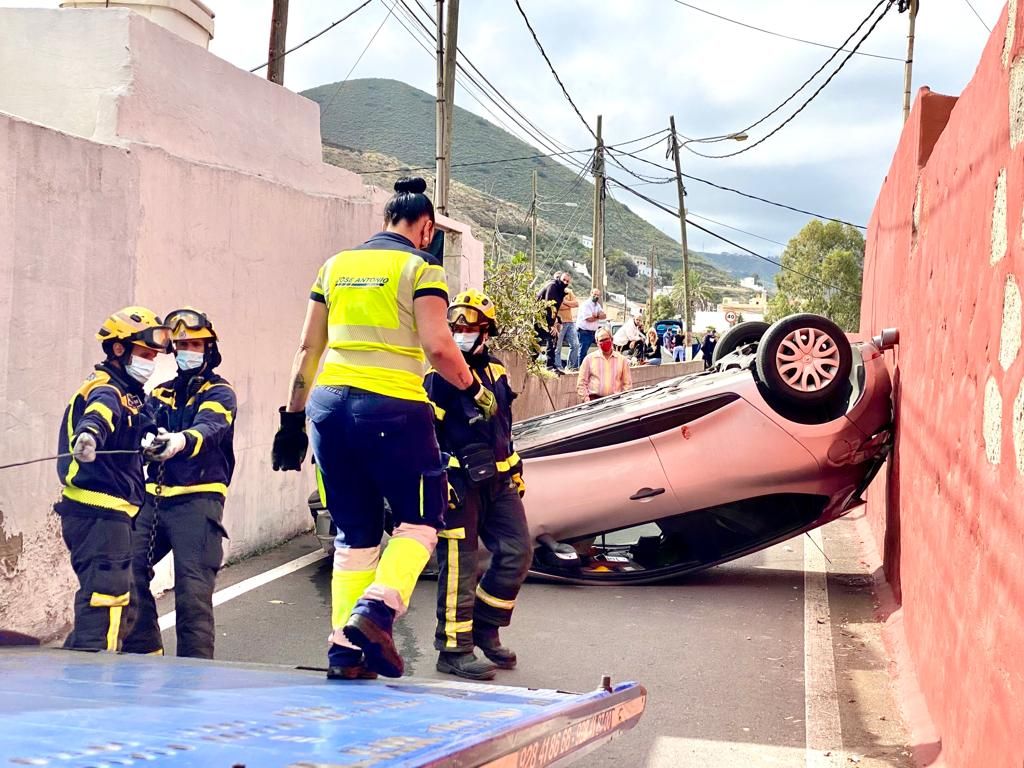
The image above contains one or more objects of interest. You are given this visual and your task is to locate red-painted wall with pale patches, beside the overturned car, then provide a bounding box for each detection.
[861,2,1024,768]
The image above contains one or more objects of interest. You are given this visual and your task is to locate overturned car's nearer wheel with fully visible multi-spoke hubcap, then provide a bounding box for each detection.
[757,314,853,404]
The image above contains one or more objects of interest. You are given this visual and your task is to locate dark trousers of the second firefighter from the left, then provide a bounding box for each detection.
[124,496,227,658]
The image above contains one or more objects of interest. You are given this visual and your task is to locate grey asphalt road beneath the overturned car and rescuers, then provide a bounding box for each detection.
[161,523,909,768]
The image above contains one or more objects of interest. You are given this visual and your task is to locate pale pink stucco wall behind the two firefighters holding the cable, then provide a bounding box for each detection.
[0,10,482,637]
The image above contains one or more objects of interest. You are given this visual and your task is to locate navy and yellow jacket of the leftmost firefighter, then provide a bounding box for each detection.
[54,364,156,520]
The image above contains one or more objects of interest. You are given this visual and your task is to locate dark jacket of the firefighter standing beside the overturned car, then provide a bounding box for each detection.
[424,349,522,481]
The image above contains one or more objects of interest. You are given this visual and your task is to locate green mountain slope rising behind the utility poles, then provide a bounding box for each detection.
[303,79,734,285]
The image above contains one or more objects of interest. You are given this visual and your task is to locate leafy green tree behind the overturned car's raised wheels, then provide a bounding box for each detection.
[765,219,864,331]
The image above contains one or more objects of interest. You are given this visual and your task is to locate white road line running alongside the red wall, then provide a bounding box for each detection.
[804,528,846,768]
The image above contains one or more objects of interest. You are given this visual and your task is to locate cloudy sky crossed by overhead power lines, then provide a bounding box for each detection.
[0,0,1005,255]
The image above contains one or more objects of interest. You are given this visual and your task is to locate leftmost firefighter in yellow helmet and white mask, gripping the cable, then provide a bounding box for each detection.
[53,306,170,651]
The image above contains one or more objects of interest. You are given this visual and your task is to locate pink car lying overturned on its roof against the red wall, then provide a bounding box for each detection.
[514,314,898,584]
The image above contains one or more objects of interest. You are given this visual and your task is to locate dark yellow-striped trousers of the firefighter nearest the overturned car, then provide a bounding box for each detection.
[434,479,532,652]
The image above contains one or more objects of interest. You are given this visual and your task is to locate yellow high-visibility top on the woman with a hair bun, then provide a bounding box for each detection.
[309,232,447,402]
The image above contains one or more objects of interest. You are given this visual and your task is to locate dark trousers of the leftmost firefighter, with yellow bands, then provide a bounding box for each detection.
[60,514,132,651]
